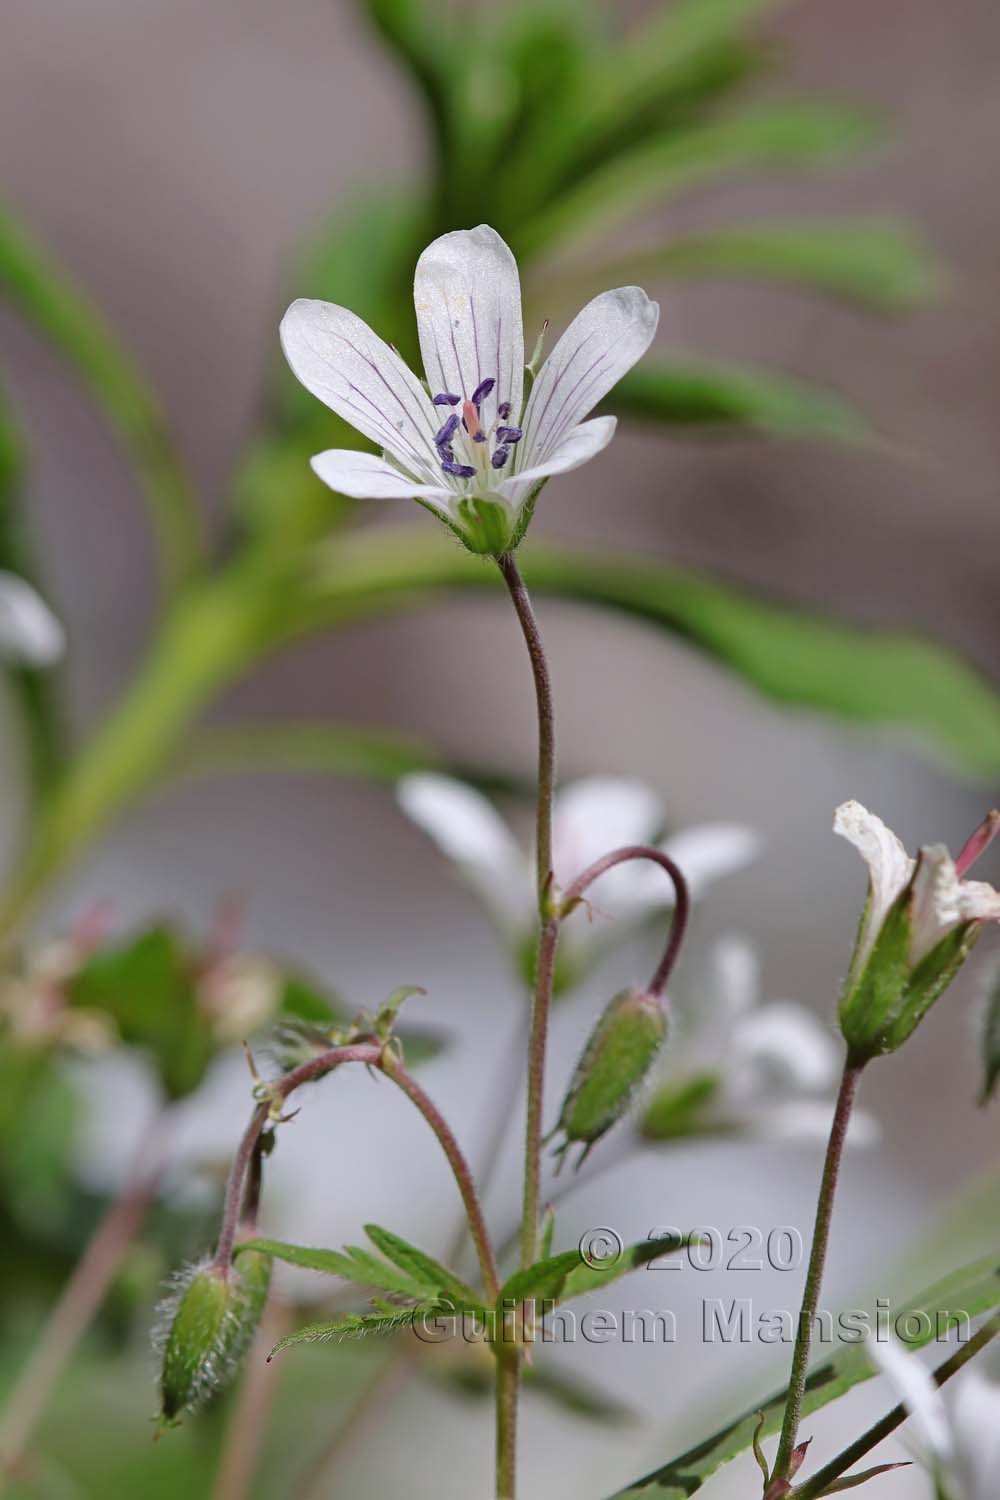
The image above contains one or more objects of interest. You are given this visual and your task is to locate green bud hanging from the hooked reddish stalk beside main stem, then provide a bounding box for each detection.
[553,989,667,1166]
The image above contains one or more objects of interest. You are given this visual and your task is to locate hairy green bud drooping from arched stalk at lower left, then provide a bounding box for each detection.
[154,1248,271,1424]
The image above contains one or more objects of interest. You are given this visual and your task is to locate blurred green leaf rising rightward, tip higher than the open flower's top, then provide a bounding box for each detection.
[519,102,876,255]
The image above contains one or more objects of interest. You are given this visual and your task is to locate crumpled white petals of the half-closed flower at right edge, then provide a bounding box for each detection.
[834,803,1000,968]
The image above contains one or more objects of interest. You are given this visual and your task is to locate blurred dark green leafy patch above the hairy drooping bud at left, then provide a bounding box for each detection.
[69,926,216,1098]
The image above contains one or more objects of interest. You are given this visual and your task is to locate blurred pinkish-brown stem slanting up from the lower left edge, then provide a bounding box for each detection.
[0,1118,163,1487]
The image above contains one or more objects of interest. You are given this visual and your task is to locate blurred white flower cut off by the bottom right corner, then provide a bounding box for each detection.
[868,1337,1000,1500]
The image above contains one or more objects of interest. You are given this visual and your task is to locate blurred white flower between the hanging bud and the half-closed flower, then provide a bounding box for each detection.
[642,936,879,1146]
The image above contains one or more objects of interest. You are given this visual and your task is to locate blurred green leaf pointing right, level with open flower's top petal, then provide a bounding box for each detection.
[588,219,945,312]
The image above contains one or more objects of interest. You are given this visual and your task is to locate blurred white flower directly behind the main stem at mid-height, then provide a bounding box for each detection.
[397,773,760,969]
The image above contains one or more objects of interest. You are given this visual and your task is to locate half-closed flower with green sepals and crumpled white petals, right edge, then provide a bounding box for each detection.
[834,803,1000,1064]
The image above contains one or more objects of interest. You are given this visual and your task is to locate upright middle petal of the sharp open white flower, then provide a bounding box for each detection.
[414,224,525,429]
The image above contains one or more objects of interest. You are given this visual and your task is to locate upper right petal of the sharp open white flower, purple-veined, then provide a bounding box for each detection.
[517,287,660,470]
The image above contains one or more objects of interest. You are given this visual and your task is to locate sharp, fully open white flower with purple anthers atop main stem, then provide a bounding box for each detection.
[280,224,660,551]
